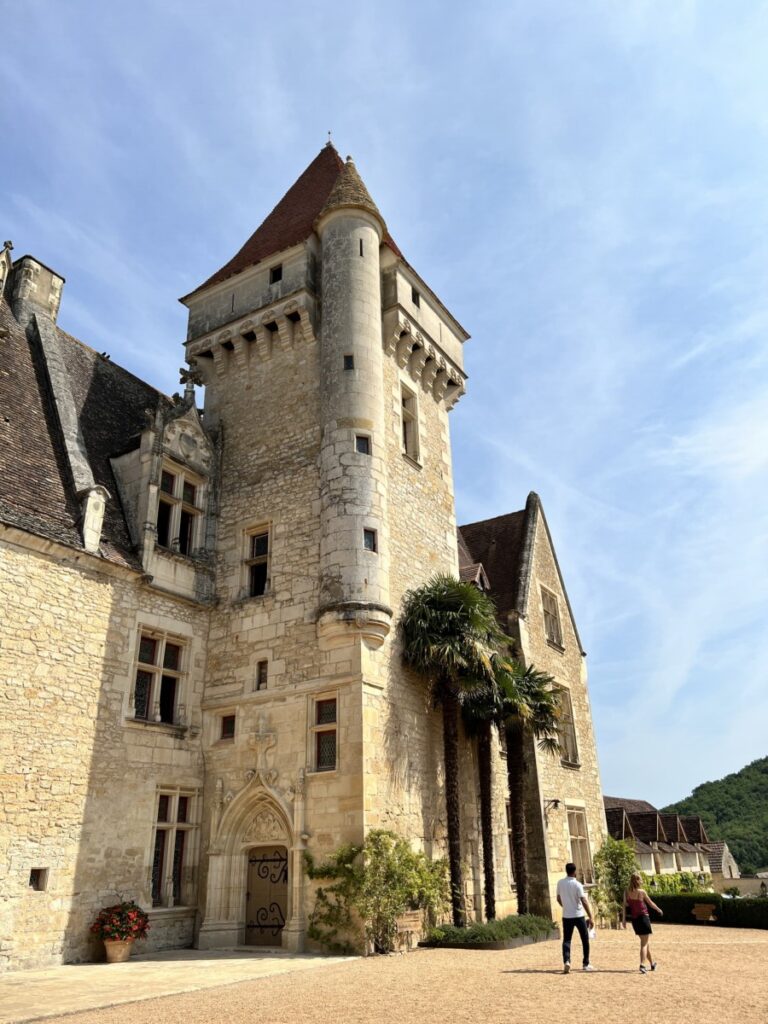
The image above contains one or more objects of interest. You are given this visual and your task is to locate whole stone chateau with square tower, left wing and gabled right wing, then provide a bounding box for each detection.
[0,143,605,968]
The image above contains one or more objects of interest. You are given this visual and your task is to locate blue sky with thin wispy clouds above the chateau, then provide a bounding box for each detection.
[0,0,768,804]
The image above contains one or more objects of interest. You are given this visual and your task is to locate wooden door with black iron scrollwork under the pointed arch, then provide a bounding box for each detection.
[245,846,288,946]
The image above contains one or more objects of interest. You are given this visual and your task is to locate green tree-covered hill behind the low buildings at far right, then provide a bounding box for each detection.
[664,757,768,874]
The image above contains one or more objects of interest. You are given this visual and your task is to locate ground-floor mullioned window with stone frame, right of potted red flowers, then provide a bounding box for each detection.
[150,784,201,909]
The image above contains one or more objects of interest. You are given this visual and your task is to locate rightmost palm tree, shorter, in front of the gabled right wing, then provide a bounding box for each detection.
[496,664,560,913]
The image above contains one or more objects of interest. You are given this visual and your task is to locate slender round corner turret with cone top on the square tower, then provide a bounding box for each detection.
[315,158,392,646]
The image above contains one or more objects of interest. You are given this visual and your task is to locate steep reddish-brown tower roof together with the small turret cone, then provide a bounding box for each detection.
[181,142,402,302]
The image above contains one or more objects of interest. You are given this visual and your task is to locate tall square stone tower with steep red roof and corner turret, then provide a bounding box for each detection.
[182,144,479,948]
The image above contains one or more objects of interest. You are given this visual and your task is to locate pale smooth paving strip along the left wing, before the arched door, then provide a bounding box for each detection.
[0,946,355,1024]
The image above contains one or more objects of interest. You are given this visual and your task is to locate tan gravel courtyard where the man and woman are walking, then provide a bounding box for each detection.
[19,925,768,1024]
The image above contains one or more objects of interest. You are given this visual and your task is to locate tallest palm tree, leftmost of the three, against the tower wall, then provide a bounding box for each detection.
[400,573,507,928]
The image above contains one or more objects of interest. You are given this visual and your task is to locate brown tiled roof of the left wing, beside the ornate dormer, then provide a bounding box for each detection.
[0,298,170,568]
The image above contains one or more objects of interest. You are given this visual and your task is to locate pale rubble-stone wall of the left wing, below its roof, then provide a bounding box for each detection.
[0,538,206,967]
